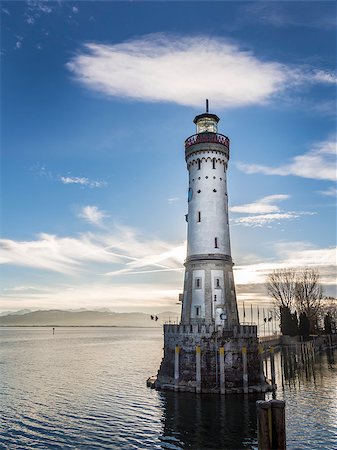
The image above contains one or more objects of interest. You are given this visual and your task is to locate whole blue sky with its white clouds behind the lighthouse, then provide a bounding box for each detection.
[0,1,336,312]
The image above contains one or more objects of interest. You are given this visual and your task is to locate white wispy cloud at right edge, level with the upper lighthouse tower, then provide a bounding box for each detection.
[237,140,337,181]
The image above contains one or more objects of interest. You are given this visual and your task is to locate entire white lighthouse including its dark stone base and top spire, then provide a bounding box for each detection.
[152,104,270,394]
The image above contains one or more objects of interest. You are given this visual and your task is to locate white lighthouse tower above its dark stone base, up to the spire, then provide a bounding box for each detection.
[181,100,239,330]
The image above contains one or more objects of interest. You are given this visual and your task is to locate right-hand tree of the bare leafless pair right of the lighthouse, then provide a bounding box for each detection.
[295,267,322,333]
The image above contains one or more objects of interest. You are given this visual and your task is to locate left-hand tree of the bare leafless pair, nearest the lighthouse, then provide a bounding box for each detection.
[266,268,297,310]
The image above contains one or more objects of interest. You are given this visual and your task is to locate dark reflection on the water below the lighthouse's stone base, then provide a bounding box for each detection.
[159,392,263,449]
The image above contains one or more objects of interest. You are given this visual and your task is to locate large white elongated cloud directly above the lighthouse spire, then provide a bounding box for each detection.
[67,34,331,108]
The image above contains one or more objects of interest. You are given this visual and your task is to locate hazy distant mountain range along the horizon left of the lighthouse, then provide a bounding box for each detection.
[0,308,177,328]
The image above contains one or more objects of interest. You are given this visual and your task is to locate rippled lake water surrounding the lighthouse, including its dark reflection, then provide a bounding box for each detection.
[0,328,337,450]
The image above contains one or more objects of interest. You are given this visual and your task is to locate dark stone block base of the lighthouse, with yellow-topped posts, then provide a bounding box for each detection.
[154,324,275,394]
